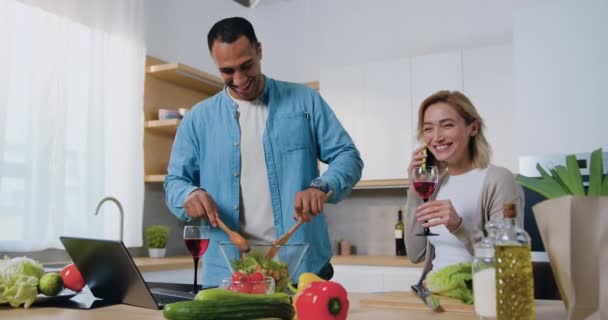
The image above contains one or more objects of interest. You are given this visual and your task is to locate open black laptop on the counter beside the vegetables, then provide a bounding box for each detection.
[59,237,195,309]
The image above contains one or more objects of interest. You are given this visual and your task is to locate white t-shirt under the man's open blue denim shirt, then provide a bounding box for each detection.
[226,89,276,241]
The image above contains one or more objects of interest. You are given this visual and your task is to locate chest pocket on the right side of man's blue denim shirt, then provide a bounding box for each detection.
[274,112,313,151]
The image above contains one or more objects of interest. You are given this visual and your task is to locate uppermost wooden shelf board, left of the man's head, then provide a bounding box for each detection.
[146,63,224,95]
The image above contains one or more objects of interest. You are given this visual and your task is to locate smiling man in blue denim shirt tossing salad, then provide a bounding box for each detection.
[164,18,363,285]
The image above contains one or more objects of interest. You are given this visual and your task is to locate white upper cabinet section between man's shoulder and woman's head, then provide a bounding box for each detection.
[320,59,412,180]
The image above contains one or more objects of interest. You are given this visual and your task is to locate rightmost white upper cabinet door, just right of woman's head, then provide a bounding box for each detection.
[462,45,519,172]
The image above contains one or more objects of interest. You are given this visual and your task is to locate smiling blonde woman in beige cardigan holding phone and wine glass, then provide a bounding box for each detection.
[405,90,523,272]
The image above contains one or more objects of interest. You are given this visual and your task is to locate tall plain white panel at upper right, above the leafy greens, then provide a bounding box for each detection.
[513,0,608,155]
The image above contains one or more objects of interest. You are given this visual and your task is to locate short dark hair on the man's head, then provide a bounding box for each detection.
[207,17,259,52]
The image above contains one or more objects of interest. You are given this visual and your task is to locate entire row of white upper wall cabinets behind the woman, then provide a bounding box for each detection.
[321,45,519,181]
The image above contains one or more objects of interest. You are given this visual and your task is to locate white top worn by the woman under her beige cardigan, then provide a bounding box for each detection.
[428,168,487,271]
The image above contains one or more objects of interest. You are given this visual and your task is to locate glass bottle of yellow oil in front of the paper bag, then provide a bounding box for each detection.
[494,203,535,320]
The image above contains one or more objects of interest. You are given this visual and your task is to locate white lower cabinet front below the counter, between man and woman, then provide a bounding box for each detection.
[332,265,422,292]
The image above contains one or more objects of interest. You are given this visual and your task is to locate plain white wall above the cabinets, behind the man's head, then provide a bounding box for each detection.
[145,0,527,82]
